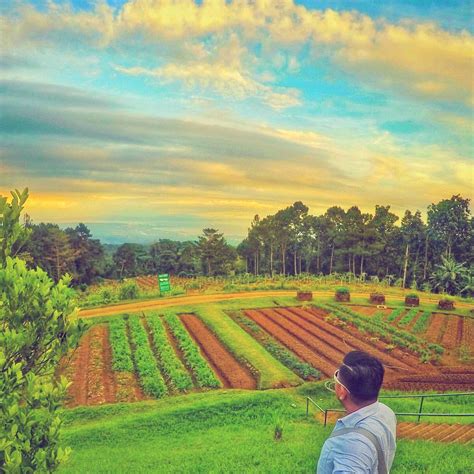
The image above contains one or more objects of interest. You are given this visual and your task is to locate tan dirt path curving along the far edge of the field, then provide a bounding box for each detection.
[79,290,472,318]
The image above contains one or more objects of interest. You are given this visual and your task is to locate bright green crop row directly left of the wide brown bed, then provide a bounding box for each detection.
[165,314,221,388]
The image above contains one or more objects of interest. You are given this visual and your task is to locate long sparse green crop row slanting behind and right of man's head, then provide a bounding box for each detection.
[318,303,444,362]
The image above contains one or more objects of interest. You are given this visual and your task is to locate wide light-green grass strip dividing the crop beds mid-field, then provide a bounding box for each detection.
[190,305,301,389]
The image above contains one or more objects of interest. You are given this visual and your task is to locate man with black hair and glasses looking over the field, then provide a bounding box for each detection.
[317,351,397,474]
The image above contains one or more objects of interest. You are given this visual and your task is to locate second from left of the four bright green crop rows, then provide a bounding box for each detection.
[129,316,167,398]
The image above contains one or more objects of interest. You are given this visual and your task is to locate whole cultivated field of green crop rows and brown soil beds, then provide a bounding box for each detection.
[62,298,474,407]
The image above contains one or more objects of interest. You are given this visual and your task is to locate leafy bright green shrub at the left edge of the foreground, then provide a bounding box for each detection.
[0,188,83,472]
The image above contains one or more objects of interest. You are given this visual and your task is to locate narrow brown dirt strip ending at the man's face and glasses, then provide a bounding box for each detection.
[244,309,337,377]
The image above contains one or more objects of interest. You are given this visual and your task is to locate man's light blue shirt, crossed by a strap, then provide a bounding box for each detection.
[317,402,397,474]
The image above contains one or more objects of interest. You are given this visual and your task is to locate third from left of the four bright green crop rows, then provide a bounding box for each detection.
[147,315,193,392]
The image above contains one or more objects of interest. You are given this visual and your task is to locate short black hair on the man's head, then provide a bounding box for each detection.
[339,351,385,403]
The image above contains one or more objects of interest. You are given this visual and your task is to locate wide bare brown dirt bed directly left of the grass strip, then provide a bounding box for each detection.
[181,314,257,390]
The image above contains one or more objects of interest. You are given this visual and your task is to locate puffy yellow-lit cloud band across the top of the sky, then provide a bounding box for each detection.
[1,0,474,105]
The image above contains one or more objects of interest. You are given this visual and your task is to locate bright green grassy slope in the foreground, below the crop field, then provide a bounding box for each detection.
[61,385,474,474]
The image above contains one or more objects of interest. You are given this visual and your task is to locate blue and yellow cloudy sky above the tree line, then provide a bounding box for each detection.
[0,0,474,243]
